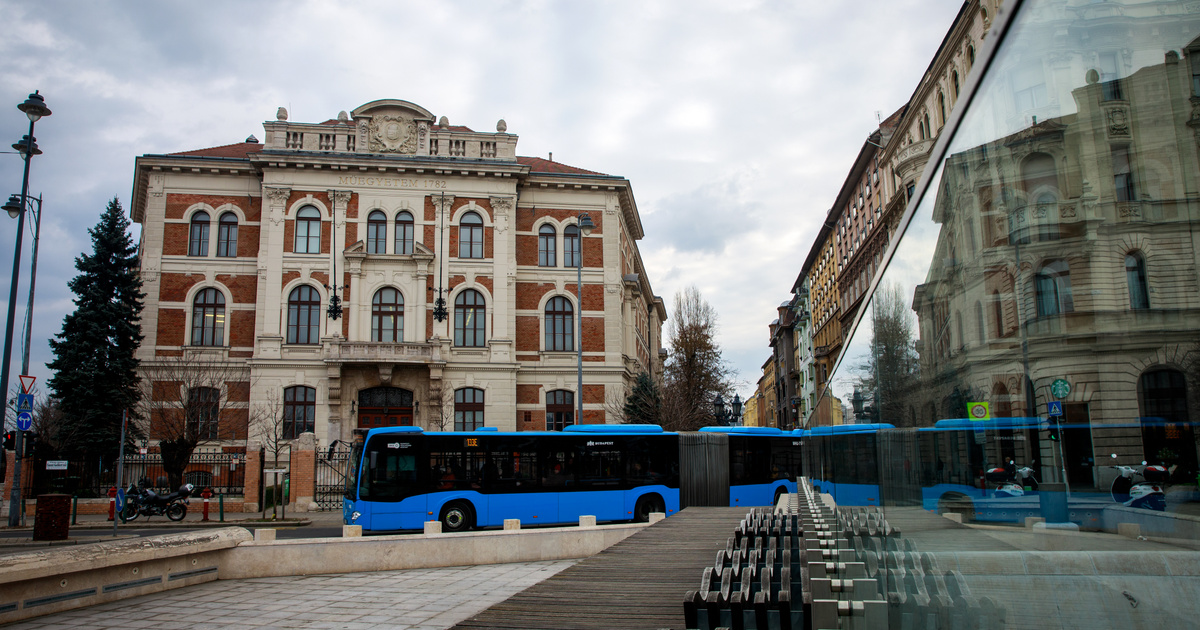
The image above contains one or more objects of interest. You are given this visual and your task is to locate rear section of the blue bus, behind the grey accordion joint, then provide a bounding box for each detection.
[700,426,800,508]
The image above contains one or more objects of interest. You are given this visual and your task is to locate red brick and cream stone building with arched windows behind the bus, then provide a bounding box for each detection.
[132,100,666,445]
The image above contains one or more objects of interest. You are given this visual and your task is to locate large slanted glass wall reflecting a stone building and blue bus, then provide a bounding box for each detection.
[805,0,1200,628]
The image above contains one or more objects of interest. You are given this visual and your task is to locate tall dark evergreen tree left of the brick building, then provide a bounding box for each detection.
[48,197,144,470]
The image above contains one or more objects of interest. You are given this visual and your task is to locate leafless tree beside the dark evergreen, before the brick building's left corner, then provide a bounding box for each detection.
[136,348,250,488]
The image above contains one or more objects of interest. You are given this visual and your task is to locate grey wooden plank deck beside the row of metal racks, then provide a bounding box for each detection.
[454,508,749,630]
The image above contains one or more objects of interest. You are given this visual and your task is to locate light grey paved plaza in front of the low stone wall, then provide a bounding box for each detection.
[4,560,577,630]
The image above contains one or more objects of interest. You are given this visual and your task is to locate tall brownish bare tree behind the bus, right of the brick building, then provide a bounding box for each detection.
[662,286,733,431]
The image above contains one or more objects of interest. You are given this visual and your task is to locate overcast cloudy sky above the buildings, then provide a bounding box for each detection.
[0,0,961,397]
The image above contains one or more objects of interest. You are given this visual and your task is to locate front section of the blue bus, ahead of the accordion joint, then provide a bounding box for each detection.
[342,425,679,532]
